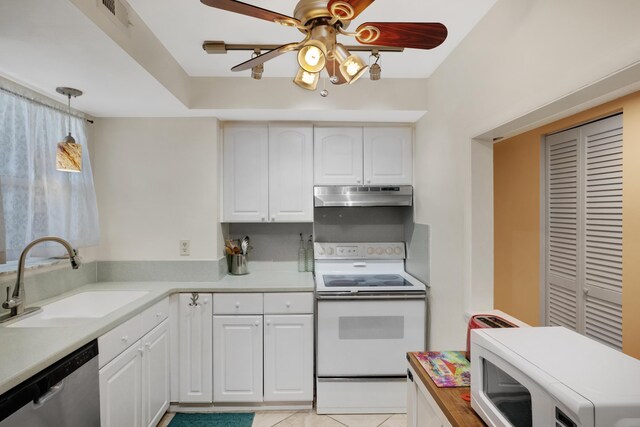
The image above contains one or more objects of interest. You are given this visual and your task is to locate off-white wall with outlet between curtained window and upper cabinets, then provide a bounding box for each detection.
[92,118,222,261]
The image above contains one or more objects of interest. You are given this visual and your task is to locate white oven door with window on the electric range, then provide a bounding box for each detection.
[317,294,426,377]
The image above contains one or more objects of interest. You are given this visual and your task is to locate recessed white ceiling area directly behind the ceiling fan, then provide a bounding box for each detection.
[129,0,495,78]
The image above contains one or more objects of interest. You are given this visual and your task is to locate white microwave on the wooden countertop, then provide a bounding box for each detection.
[471,327,640,427]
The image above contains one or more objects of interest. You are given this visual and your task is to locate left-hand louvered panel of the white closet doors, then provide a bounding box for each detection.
[546,129,580,330]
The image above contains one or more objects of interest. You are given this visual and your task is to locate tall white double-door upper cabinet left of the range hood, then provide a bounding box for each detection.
[223,123,313,222]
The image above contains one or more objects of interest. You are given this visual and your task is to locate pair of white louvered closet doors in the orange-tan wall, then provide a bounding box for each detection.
[546,115,622,349]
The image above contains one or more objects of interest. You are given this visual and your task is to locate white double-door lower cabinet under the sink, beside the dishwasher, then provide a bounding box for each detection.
[99,320,169,427]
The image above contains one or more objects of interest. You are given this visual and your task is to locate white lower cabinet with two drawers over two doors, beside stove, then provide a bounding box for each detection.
[213,292,313,403]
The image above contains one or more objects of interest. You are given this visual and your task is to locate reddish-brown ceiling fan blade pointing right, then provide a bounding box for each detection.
[356,22,447,49]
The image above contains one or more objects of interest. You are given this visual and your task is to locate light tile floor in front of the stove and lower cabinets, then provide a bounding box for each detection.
[158,410,407,427]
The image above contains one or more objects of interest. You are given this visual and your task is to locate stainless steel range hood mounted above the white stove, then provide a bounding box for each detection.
[313,185,413,208]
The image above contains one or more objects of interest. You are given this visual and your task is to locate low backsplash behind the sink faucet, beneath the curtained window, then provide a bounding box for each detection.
[0,261,97,314]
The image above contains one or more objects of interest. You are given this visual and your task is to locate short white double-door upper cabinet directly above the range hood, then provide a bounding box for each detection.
[314,126,413,185]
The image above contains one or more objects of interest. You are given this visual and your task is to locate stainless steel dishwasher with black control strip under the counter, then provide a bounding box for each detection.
[0,340,100,427]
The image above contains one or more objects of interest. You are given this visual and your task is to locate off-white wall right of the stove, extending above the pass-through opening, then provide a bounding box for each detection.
[415,0,640,349]
